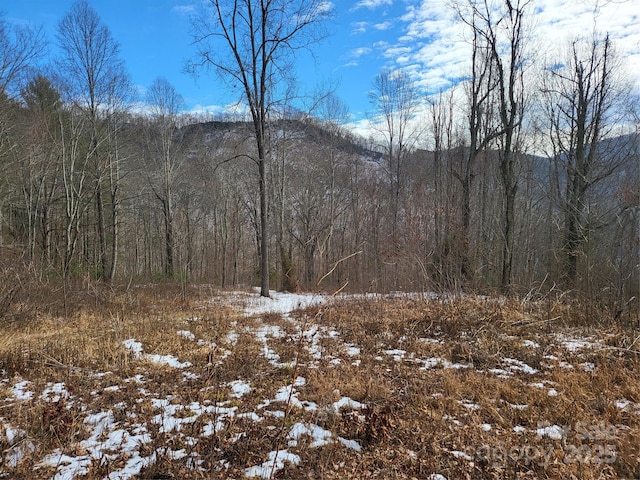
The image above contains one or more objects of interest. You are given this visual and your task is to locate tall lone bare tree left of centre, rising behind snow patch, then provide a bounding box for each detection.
[191,0,330,297]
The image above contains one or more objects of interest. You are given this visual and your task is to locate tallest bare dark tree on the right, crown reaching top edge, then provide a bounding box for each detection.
[458,0,530,290]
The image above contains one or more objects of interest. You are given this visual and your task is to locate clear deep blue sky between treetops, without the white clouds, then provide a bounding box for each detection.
[0,0,412,124]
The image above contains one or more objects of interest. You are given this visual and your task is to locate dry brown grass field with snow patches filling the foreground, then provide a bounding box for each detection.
[0,285,640,480]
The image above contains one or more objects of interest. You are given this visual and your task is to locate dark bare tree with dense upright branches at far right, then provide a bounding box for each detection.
[544,36,624,288]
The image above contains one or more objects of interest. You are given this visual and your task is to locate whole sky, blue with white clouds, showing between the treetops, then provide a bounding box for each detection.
[0,0,640,133]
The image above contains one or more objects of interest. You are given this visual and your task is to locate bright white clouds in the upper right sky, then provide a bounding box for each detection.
[380,0,640,95]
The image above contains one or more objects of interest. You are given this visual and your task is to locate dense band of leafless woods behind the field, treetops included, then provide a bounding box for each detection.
[0,1,640,308]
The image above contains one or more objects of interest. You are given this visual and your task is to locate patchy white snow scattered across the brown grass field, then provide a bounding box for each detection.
[0,292,640,480]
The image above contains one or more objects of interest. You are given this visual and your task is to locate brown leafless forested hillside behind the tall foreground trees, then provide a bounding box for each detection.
[2,106,638,302]
